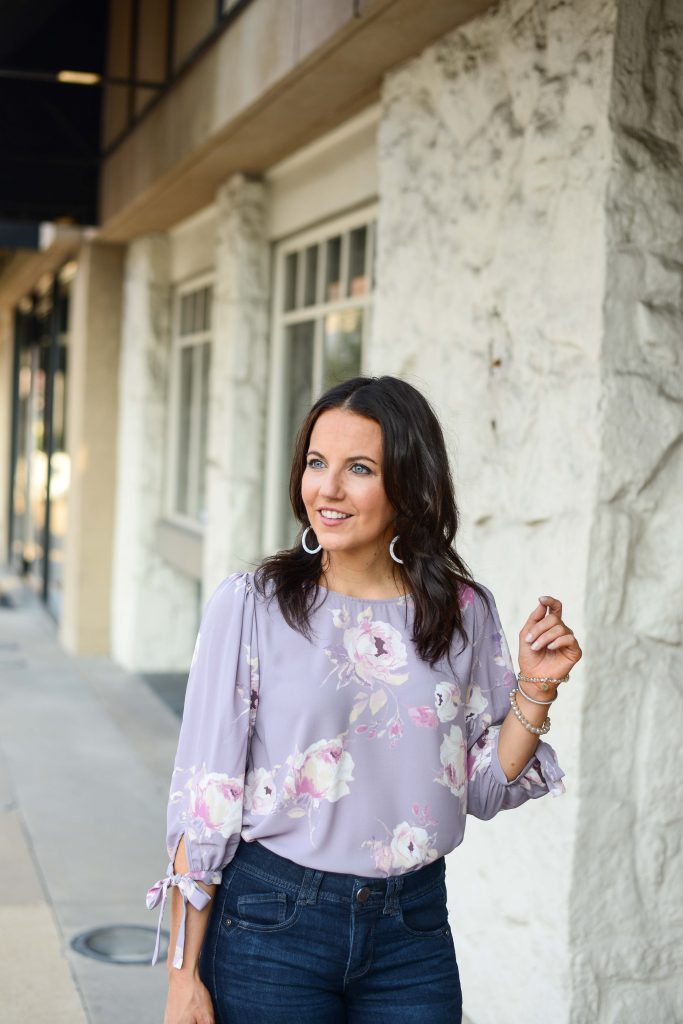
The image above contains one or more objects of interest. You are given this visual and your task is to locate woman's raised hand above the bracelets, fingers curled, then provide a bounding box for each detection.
[518,597,583,679]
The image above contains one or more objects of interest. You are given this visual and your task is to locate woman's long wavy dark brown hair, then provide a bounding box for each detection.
[254,376,488,666]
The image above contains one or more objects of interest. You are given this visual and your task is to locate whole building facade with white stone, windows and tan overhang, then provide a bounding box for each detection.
[0,0,683,1024]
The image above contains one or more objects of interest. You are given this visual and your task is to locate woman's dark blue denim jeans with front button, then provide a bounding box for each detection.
[200,840,462,1024]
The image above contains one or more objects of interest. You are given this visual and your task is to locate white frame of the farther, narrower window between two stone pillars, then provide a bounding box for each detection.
[164,270,216,537]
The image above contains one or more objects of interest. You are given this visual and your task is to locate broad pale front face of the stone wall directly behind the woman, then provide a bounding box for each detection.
[370,0,618,1024]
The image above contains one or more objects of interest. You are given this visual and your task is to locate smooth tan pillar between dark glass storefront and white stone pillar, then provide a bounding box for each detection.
[59,243,124,654]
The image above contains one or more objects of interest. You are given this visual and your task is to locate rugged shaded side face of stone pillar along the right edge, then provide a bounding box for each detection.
[569,0,683,1024]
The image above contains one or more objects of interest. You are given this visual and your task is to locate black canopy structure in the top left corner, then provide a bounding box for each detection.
[0,0,108,232]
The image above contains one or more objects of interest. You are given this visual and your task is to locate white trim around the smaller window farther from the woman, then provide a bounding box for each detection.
[164,271,215,537]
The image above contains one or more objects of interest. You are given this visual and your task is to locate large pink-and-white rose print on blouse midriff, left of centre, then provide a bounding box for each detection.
[283,736,355,803]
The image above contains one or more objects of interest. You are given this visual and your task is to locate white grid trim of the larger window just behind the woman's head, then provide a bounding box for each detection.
[262,202,379,553]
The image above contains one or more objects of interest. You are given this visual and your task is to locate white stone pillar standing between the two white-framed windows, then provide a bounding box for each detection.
[203,174,268,599]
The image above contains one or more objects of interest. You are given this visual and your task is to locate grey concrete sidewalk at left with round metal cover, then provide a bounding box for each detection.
[0,580,179,1024]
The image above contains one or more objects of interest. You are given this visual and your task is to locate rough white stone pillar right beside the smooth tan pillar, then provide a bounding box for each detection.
[112,234,199,671]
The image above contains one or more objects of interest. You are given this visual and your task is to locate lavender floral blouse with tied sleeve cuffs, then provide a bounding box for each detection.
[147,572,564,968]
